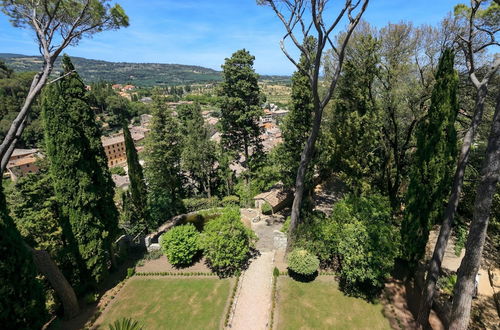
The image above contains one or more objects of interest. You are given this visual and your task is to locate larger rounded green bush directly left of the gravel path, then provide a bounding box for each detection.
[201,208,256,275]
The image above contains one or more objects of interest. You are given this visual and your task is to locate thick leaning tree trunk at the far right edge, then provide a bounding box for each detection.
[450,94,500,330]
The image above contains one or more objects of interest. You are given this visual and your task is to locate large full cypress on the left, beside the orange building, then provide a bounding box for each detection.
[42,55,118,285]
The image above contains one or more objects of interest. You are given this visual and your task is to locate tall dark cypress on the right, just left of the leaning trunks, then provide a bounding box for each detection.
[401,49,458,267]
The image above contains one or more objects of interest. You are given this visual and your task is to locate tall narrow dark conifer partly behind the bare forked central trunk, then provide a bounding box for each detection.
[277,37,316,188]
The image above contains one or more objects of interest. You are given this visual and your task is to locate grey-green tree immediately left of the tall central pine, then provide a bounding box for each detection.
[177,104,217,197]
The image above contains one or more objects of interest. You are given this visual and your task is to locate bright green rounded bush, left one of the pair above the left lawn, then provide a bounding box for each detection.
[161,224,200,266]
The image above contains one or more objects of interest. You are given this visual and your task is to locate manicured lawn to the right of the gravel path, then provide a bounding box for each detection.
[276,276,391,329]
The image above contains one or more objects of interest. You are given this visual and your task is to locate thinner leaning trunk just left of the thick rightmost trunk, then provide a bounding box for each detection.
[417,83,488,328]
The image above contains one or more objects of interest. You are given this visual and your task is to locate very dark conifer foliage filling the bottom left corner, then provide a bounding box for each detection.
[0,185,47,329]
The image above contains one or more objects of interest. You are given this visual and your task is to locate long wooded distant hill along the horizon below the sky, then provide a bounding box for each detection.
[0,53,290,87]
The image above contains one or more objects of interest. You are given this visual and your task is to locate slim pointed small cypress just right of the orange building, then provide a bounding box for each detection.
[123,124,150,233]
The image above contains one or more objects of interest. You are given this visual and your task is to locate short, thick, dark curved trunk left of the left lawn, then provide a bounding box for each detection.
[26,245,80,319]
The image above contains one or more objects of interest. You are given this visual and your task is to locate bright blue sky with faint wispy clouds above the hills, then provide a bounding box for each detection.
[0,0,464,74]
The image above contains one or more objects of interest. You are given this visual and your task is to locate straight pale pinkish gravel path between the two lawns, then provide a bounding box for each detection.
[229,251,274,330]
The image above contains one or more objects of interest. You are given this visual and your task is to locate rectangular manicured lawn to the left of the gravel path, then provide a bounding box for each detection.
[96,276,234,330]
